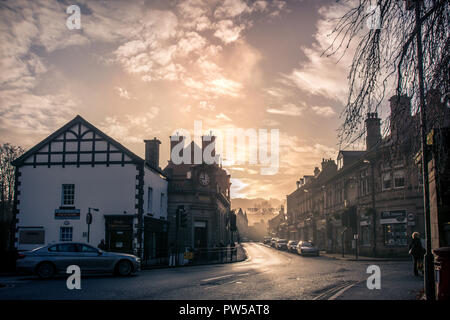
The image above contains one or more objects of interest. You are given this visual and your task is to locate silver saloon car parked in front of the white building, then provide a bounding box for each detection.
[16,242,141,279]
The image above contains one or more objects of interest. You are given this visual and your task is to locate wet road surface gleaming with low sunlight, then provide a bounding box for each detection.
[0,242,423,300]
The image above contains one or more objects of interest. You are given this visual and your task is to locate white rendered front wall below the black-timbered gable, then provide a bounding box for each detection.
[17,164,137,250]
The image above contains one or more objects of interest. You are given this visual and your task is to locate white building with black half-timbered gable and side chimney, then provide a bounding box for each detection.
[13,116,168,264]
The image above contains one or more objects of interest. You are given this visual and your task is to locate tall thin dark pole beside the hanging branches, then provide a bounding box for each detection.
[415,0,435,300]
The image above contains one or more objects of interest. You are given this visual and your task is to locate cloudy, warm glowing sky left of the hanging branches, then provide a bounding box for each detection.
[0,0,376,199]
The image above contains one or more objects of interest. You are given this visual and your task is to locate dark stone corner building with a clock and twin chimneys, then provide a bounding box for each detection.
[164,136,237,262]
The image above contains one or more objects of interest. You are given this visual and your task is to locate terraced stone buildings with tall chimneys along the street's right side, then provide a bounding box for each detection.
[287,92,448,256]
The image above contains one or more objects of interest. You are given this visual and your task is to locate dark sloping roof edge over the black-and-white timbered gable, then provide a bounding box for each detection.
[11,115,166,177]
